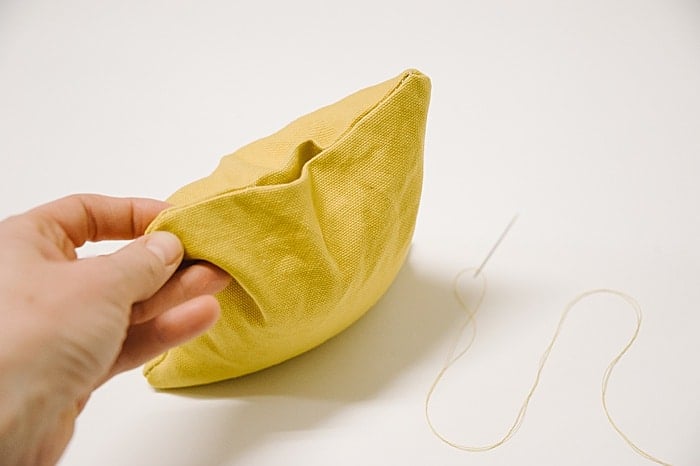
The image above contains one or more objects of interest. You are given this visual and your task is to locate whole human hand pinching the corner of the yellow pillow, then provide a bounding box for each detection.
[0,195,230,465]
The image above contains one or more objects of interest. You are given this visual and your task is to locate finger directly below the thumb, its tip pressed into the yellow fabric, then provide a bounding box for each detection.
[131,263,231,324]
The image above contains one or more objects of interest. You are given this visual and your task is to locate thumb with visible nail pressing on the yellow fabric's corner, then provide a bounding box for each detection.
[88,231,184,305]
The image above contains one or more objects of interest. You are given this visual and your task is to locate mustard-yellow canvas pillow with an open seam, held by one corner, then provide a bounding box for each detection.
[144,70,430,388]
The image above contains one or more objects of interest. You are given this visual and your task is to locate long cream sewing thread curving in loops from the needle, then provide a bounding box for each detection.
[425,268,671,466]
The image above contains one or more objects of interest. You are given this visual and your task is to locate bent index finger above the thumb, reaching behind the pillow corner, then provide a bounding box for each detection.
[26,194,168,253]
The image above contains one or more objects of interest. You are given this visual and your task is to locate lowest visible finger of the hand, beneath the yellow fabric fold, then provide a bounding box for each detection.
[108,295,221,377]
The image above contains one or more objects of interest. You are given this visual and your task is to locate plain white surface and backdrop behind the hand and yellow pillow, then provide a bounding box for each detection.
[0,0,700,466]
